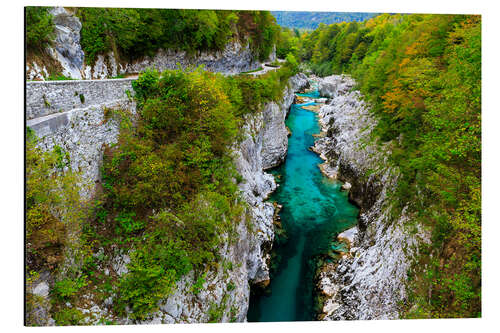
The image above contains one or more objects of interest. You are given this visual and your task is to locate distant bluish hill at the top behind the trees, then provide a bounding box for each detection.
[271,11,377,29]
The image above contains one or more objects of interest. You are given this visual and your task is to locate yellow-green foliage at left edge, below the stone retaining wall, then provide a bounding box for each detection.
[25,132,84,270]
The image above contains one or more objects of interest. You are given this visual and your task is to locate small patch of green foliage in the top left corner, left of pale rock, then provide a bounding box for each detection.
[25,7,55,51]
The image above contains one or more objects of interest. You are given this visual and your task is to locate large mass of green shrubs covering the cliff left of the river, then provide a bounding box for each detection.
[87,68,241,319]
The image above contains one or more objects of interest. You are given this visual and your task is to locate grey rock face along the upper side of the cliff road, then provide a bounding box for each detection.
[26,7,270,80]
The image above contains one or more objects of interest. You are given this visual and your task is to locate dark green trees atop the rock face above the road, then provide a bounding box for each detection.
[76,7,278,64]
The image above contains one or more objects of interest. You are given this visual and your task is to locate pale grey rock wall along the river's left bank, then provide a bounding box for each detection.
[125,74,308,324]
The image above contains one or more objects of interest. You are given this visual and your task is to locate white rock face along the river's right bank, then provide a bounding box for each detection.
[315,76,428,320]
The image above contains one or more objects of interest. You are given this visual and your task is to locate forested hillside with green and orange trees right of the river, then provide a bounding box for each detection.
[296,14,481,317]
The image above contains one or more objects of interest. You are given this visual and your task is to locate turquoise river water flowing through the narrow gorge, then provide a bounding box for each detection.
[248,91,358,322]
